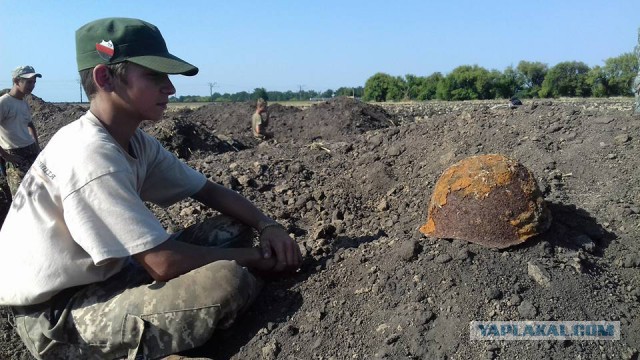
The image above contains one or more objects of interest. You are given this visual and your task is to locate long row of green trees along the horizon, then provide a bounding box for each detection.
[171,53,639,102]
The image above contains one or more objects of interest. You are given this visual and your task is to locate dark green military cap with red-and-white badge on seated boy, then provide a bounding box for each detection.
[76,18,198,76]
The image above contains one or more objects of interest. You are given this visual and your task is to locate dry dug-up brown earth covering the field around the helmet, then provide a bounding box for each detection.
[0,98,640,360]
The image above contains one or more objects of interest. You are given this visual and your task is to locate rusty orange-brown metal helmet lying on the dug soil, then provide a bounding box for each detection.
[420,154,551,248]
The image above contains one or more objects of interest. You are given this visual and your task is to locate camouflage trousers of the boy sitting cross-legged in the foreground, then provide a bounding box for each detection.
[13,216,261,359]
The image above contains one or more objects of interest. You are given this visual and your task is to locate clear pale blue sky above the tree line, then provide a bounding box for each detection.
[0,0,640,102]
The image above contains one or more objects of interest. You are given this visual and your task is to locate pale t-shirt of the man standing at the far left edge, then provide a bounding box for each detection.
[0,94,35,149]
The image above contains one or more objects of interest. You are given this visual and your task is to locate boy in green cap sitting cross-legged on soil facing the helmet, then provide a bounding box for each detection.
[0,18,302,359]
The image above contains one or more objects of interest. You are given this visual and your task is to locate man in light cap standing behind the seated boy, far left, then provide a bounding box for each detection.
[0,65,42,195]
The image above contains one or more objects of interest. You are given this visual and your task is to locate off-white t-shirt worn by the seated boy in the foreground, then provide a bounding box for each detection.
[0,112,206,305]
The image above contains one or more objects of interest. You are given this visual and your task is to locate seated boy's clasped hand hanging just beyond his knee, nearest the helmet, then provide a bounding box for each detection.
[259,224,302,271]
